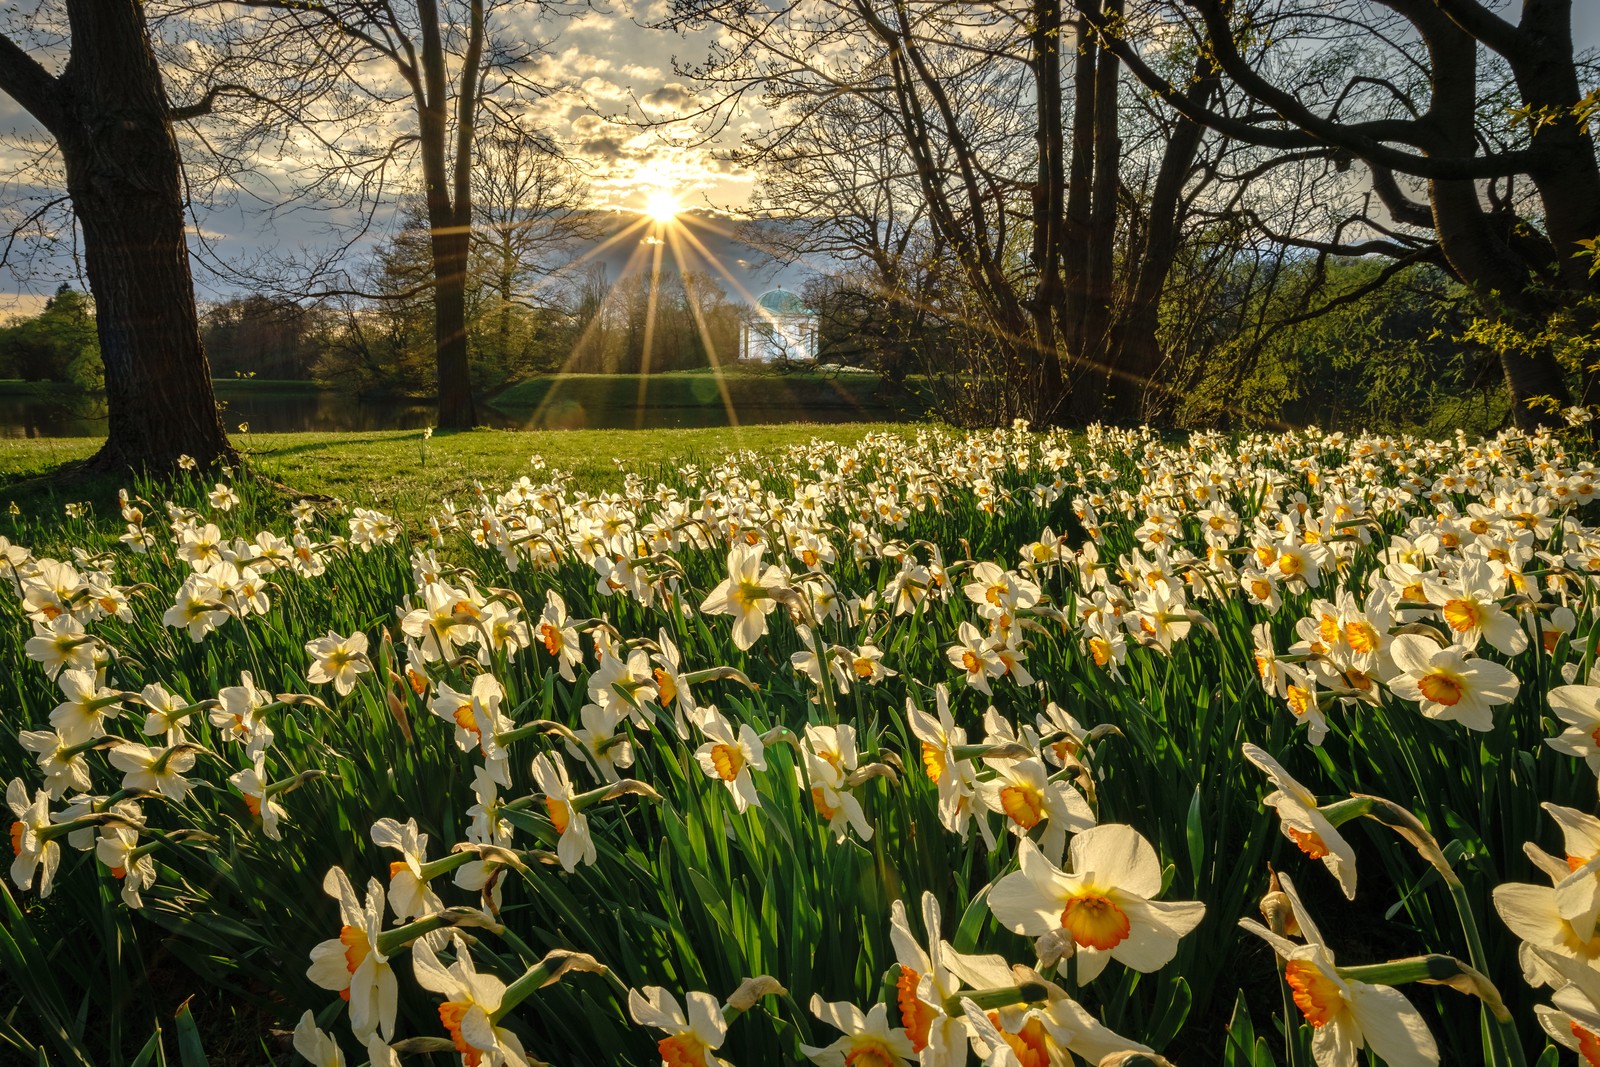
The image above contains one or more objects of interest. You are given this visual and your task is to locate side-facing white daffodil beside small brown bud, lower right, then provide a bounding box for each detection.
[1238,875,1438,1067]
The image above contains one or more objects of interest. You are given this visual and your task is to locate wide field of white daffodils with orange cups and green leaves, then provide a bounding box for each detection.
[0,426,1600,1067]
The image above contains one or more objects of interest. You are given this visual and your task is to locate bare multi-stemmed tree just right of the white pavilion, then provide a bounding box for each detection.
[672,0,1221,421]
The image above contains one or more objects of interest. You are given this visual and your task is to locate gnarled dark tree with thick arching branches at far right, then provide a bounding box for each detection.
[1090,0,1600,426]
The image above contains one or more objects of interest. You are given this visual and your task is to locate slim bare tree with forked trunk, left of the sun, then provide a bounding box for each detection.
[171,0,566,427]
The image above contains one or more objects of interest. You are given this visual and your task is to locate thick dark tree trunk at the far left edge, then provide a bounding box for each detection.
[0,0,234,469]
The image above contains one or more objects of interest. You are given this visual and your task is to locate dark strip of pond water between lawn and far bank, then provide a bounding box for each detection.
[0,382,893,438]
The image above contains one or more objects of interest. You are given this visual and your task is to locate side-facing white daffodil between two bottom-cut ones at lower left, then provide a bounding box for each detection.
[306,867,396,1041]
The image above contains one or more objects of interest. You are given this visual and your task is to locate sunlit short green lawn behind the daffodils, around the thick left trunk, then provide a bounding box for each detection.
[0,422,912,520]
